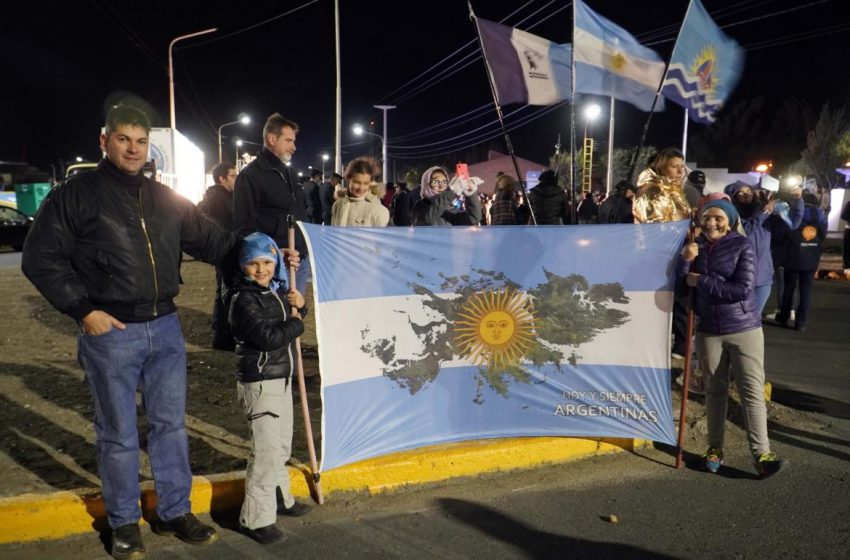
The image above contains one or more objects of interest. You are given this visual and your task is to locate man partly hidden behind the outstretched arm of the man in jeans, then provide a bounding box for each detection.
[198,162,237,351]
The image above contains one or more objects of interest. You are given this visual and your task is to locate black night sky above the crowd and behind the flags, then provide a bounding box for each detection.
[0,0,850,176]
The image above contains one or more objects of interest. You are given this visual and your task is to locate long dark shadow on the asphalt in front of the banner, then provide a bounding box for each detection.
[437,498,675,560]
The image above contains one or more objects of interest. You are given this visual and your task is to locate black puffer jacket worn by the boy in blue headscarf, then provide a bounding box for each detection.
[230,280,306,383]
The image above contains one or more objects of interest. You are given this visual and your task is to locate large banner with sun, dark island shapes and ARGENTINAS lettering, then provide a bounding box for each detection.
[301,222,688,469]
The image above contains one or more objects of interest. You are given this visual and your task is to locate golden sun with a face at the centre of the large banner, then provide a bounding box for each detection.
[454,288,534,369]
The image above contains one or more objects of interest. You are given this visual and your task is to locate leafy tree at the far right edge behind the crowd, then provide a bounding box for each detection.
[800,103,850,189]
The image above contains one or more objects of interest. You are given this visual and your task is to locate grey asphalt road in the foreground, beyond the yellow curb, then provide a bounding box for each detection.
[0,433,850,560]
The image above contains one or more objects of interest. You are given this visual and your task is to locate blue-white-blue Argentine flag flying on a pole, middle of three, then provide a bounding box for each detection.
[573,0,664,111]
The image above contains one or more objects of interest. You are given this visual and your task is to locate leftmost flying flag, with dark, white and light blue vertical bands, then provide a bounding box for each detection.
[475,17,571,105]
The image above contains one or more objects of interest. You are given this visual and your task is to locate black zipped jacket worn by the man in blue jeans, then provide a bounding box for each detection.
[22,159,236,323]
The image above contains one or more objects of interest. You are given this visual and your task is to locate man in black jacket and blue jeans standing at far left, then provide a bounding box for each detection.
[22,105,236,558]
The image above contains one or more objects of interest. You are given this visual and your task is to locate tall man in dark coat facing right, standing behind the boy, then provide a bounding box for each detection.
[233,113,311,290]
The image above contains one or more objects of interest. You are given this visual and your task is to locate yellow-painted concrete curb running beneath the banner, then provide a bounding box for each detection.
[0,437,636,544]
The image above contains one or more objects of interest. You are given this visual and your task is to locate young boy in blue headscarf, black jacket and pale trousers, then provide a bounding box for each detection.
[229,233,310,544]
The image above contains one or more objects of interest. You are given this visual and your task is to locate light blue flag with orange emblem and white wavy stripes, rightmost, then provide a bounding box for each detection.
[661,0,744,124]
